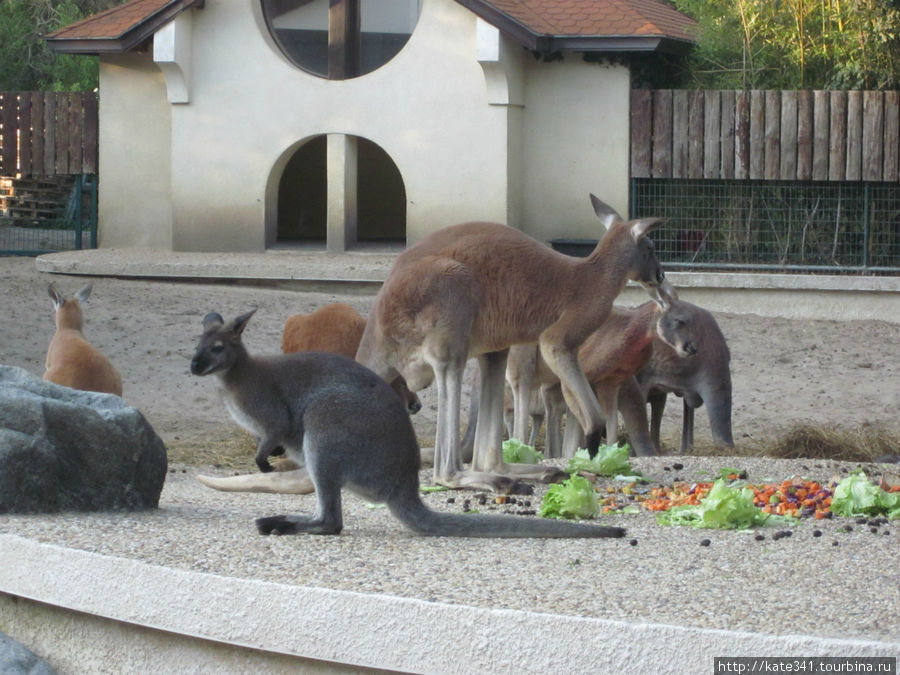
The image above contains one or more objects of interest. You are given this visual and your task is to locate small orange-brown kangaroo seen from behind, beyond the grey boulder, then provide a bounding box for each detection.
[44,284,122,396]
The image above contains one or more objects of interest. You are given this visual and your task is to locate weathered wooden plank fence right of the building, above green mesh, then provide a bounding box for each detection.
[631,89,900,182]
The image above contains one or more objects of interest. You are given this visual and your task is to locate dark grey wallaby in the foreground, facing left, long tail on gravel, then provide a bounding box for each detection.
[191,310,625,537]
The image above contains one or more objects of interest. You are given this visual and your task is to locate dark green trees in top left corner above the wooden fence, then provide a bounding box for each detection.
[0,0,122,91]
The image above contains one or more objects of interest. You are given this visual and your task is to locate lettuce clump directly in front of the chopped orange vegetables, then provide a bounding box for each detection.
[656,478,769,530]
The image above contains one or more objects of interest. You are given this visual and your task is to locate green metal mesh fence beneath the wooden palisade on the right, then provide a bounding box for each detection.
[631,179,900,274]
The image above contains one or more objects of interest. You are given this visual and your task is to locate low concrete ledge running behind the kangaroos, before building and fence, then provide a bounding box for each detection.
[36,247,900,323]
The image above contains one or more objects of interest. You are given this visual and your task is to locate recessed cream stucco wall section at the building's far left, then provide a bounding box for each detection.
[97,53,172,249]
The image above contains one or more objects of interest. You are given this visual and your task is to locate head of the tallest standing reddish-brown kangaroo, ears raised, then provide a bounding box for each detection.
[591,195,666,288]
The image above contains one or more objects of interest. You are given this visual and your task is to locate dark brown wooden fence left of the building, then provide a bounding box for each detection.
[0,91,97,176]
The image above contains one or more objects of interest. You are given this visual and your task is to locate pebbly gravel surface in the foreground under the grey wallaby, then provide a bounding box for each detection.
[0,457,900,643]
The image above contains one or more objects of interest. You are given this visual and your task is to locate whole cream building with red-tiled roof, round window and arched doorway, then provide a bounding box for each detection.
[47,0,693,251]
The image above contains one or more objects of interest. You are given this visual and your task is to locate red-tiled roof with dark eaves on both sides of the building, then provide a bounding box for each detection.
[46,0,695,53]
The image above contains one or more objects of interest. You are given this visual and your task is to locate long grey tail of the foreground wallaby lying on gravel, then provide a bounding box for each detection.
[388,493,625,538]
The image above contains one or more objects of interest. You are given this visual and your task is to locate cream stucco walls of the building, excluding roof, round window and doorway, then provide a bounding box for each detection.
[100,0,628,251]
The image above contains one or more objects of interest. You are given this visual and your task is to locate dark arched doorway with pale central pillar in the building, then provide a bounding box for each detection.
[275,134,406,251]
